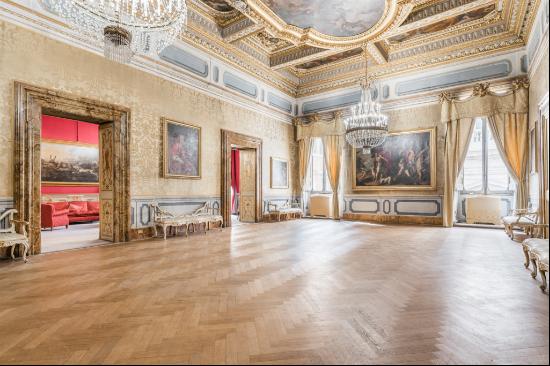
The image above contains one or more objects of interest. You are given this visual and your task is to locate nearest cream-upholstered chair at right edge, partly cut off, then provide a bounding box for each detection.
[522,224,548,292]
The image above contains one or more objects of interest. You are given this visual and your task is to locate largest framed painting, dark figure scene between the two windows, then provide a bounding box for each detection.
[352,128,436,191]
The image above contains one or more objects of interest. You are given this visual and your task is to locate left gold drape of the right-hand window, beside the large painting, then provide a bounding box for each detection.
[443,118,474,227]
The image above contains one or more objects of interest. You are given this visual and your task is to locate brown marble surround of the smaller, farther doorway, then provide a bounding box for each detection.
[221,130,263,227]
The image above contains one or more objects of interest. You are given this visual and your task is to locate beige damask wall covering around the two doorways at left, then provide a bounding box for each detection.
[0,22,296,197]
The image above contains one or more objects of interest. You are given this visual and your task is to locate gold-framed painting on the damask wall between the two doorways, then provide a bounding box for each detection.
[162,118,201,179]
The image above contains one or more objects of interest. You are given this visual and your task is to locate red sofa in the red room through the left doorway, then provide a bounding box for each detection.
[40,201,99,230]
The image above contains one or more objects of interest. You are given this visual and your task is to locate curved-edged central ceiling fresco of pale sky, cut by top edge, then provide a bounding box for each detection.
[264,0,385,37]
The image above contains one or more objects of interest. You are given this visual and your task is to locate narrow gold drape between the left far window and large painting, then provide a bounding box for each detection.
[323,135,344,220]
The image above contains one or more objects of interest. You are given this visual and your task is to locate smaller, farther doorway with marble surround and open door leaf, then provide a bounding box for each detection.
[221,130,263,227]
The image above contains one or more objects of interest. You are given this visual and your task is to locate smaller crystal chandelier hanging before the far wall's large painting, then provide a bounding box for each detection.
[344,50,388,153]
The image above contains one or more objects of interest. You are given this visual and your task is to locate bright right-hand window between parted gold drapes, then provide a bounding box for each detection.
[458,118,515,194]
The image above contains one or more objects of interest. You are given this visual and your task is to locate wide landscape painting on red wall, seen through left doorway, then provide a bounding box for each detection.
[40,140,99,186]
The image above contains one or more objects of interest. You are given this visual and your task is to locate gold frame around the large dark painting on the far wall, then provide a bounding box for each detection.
[351,127,437,191]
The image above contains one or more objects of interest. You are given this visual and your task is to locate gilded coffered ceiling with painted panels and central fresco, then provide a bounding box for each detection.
[188,0,540,97]
